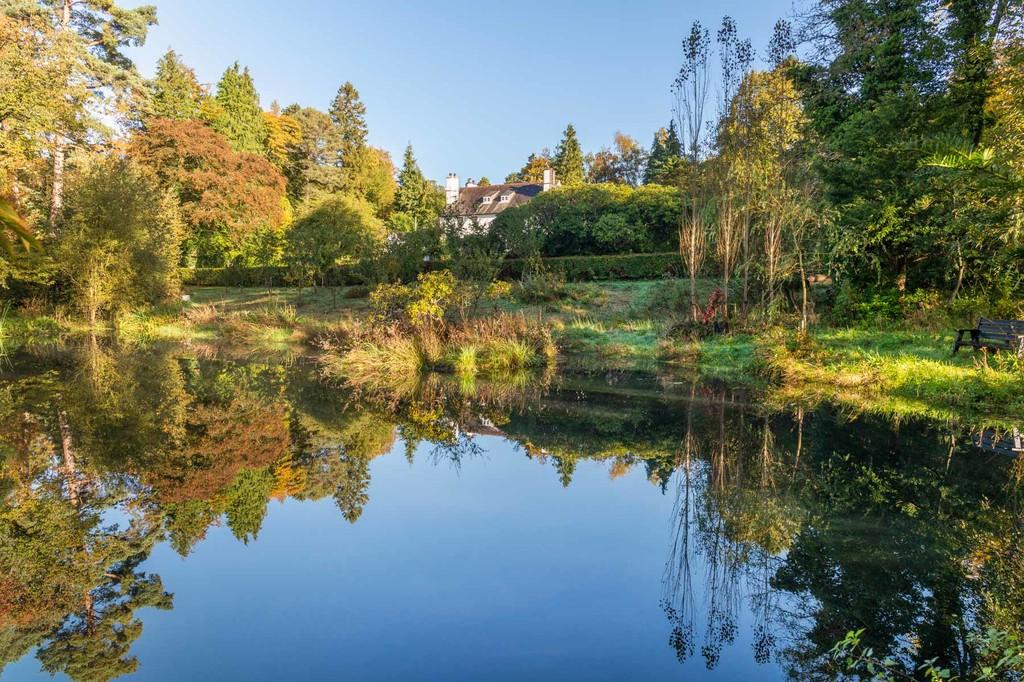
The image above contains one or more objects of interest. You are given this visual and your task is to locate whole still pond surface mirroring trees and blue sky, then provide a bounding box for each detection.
[0,344,1024,680]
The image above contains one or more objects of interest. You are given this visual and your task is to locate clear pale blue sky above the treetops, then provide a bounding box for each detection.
[133,0,792,181]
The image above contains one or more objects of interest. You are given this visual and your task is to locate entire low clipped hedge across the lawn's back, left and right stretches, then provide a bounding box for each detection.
[181,252,682,287]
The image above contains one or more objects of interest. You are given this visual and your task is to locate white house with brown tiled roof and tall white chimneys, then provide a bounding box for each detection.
[441,168,558,231]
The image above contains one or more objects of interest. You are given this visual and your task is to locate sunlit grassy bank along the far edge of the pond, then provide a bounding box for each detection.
[0,281,1024,427]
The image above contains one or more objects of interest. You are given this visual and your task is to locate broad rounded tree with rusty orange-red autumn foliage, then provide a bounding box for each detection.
[129,119,285,266]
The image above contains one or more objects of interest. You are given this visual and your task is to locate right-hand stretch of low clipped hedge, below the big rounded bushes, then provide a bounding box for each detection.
[501,252,682,282]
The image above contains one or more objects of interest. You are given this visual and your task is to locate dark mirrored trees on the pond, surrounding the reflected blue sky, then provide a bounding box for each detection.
[0,342,1024,680]
